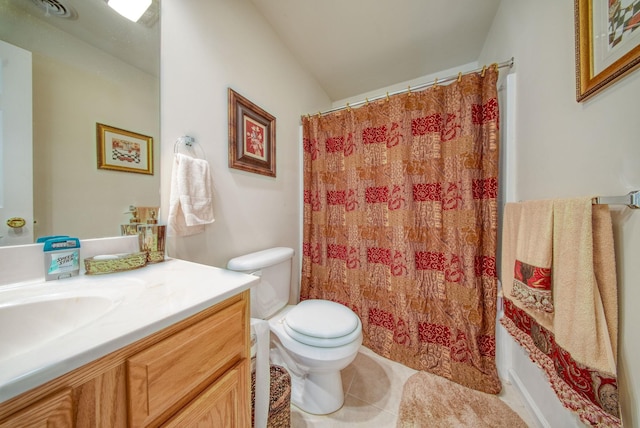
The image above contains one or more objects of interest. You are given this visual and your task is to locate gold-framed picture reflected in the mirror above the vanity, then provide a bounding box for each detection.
[96,123,153,175]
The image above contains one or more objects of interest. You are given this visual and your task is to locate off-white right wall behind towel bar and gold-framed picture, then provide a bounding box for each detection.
[478,0,640,427]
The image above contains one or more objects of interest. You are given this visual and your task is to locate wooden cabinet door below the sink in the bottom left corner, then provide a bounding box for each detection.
[0,389,73,428]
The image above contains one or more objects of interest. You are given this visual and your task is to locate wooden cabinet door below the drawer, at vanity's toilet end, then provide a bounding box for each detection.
[162,359,251,428]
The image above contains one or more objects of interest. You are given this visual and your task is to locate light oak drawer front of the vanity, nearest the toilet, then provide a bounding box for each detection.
[127,300,248,427]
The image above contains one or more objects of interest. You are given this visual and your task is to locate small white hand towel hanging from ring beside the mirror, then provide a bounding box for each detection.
[167,153,214,236]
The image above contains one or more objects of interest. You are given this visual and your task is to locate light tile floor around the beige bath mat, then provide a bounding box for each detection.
[291,347,537,428]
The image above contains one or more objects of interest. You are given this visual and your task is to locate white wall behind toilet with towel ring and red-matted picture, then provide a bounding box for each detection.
[161,0,330,300]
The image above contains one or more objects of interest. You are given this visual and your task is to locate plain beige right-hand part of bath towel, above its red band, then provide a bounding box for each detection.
[553,198,618,374]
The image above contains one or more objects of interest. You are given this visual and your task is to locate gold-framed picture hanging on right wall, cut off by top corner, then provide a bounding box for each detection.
[575,0,640,102]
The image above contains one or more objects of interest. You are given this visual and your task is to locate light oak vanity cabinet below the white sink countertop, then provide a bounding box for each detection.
[0,291,251,428]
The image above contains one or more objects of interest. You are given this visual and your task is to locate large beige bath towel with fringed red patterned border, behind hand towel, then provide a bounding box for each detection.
[500,198,621,427]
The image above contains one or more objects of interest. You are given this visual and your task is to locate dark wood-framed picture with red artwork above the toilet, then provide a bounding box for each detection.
[229,88,276,177]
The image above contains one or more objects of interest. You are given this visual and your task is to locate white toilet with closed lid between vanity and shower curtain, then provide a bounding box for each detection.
[227,247,362,415]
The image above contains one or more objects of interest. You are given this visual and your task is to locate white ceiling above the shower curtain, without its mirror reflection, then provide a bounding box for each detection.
[251,0,500,101]
